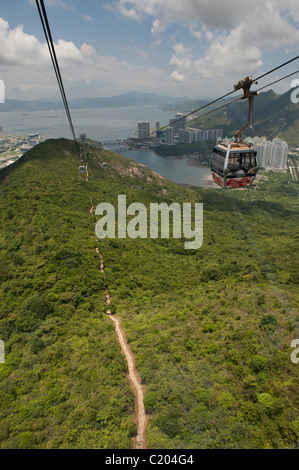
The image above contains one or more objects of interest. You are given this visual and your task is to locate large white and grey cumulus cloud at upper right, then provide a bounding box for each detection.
[111,0,299,82]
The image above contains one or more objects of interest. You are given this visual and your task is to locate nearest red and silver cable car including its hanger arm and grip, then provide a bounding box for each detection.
[211,77,258,189]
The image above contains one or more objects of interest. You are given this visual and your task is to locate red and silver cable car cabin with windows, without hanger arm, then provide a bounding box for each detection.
[211,142,258,189]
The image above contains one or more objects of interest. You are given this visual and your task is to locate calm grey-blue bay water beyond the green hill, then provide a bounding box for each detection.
[0,106,215,187]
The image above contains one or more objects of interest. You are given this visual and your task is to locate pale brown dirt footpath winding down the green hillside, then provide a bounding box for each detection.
[91,244,147,449]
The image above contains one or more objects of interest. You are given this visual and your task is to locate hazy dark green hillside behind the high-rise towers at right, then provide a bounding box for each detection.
[191,90,299,147]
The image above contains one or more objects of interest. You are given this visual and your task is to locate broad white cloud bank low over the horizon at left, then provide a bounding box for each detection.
[0,18,180,99]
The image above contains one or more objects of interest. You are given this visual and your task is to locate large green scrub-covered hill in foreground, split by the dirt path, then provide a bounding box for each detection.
[0,139,299,449]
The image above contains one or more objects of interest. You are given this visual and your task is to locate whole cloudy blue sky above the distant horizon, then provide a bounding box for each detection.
[0,0,299,99]
